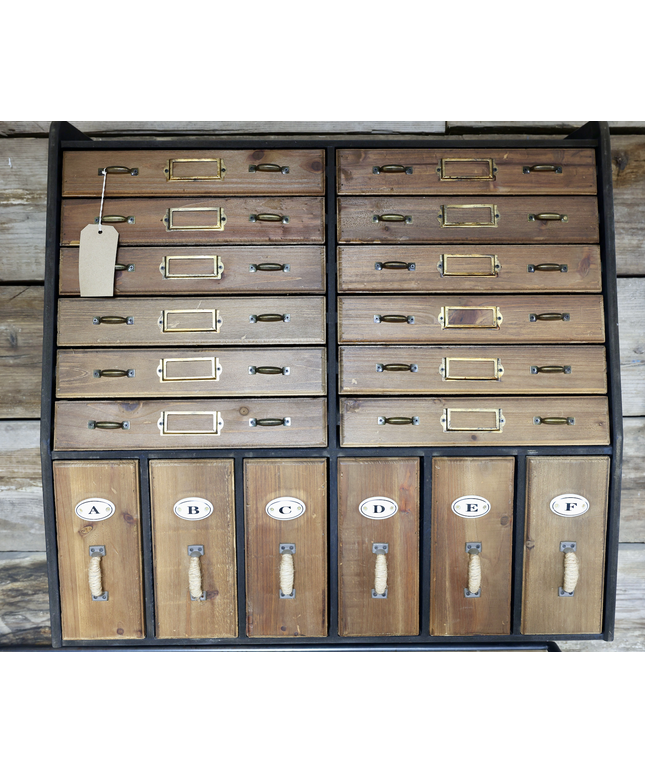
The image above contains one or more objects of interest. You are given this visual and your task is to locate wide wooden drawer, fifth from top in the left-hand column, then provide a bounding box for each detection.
[56,347,327,398]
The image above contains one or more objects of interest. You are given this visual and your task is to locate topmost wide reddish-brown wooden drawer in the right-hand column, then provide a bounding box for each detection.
[337,148,596,196]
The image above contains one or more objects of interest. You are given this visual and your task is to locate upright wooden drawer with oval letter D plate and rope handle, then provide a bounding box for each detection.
[338,457,419,637]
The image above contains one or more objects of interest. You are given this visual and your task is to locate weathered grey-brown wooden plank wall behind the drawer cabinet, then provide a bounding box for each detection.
[0,122,645,651]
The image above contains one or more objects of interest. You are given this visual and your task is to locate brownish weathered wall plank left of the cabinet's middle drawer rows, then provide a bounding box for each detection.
[0,286,44,419]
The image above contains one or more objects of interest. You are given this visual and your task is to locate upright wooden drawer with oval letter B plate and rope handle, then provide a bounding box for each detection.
[150,460,237,638]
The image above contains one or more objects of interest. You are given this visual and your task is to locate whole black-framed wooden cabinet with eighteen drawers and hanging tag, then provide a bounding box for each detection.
[42,122,622,650]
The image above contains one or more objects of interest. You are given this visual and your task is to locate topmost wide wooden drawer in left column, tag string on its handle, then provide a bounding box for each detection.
[62,149,325,196]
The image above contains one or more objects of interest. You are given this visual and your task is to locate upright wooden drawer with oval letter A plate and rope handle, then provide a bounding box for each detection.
[53,460,144,640]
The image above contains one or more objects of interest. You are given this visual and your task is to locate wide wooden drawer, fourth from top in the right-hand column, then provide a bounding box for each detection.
[338,296,605,344]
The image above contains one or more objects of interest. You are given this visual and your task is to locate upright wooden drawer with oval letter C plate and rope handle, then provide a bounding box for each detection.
[244,459,327,638]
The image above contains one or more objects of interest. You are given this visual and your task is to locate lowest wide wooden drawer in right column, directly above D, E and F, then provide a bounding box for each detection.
[340,396,609,447]
